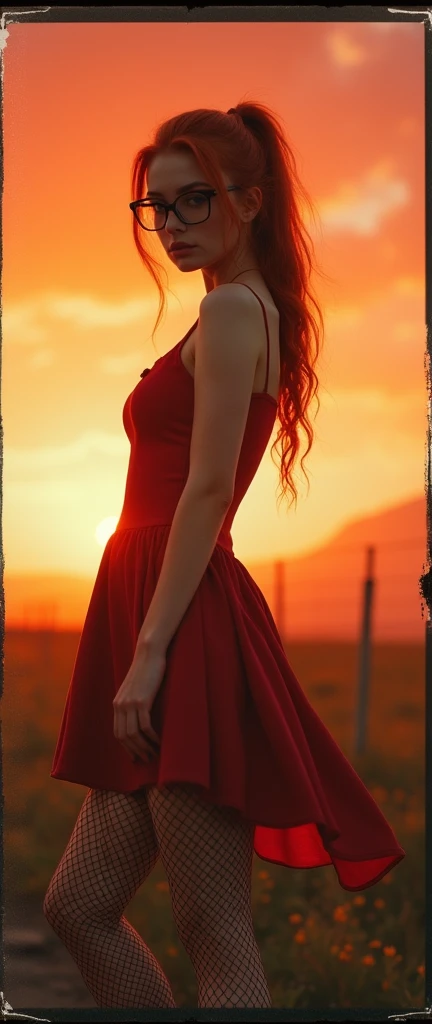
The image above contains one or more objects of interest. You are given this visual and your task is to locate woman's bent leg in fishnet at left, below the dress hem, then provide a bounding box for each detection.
[43,790,176,1009]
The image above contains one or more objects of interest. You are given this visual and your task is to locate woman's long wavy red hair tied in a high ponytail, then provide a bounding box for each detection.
[132,102,323,505]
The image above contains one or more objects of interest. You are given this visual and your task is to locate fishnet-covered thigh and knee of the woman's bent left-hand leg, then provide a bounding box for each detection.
[44,788,159,922]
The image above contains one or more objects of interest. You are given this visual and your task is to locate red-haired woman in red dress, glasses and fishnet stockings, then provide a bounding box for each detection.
[44,102,404,1008]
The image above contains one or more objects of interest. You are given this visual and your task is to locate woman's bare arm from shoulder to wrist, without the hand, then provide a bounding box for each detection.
[137,284,264,653]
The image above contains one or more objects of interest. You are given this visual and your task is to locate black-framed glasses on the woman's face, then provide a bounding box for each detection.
[129,185,244,231]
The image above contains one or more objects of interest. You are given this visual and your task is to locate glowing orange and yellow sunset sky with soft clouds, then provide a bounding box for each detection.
[2,15,427,575]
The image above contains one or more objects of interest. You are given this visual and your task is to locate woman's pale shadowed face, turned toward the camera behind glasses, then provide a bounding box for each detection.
[143,150,250,272]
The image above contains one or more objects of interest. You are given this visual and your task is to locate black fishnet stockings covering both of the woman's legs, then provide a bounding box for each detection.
[44,783,271,1009]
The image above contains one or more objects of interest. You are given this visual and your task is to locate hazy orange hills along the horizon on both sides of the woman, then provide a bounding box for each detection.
[4,498,427,642]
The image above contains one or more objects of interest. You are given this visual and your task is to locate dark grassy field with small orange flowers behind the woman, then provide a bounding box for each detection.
[2,631,425,1012]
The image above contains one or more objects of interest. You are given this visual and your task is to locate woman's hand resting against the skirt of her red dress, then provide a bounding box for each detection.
[113,648,167,761]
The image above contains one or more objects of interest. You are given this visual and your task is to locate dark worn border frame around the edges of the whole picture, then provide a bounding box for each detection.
[0,4,432,1021]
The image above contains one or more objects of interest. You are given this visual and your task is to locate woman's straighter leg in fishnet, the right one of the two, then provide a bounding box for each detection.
[147,783,271,1008]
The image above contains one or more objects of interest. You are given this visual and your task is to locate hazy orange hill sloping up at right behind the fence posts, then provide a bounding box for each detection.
[247,498,427,641]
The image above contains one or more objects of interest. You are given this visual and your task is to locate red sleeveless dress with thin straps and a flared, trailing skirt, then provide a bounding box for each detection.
[50,282,404,891]
